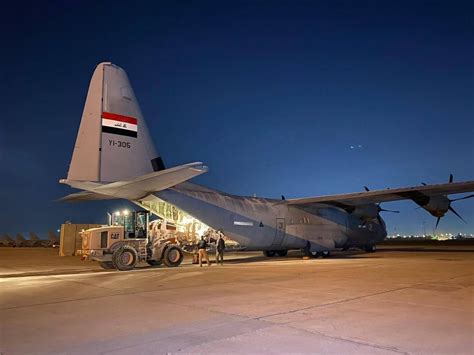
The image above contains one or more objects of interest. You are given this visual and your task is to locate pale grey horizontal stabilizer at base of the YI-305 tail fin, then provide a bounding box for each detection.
[61,162,208,201]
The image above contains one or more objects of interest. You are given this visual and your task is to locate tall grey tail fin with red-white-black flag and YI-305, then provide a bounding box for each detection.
[67,62,165,183]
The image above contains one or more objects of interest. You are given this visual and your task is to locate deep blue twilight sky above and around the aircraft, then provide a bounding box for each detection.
[0,1,474,239]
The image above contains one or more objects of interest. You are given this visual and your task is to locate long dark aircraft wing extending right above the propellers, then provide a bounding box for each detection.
[285,181,474,207]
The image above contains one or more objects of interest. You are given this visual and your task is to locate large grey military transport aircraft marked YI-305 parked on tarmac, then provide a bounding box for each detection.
[60,63,474,256]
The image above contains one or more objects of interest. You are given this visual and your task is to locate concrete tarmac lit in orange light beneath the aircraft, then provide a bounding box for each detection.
[0,247,474,355]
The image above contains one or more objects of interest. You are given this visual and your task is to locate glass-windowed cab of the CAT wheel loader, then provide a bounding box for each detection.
[109,210,149,239]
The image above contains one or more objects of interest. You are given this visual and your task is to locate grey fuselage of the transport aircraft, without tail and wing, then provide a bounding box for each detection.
[155,183,387,251]
